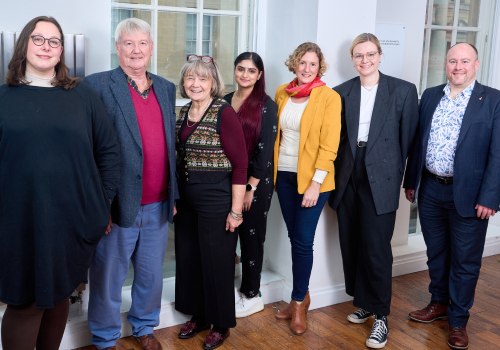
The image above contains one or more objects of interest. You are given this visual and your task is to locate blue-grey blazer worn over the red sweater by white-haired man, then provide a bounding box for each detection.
[84,67,179,227]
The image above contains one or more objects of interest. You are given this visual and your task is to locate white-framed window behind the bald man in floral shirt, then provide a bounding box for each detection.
[409,0,497,234]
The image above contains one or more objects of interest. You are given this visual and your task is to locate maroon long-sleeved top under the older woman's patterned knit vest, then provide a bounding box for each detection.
[181,106,248,185]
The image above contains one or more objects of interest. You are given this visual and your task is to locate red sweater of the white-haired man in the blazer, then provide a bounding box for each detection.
[128,85,168,204]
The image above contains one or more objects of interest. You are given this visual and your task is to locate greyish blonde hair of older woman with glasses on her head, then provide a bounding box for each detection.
[179,60,226,98]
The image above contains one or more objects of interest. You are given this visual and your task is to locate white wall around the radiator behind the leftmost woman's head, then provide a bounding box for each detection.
[0,0,111,75]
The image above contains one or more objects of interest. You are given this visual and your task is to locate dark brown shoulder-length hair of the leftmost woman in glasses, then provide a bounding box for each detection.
[5,16,80,90]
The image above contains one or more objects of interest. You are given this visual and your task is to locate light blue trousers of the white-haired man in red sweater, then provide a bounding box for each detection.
[88,199,168,349]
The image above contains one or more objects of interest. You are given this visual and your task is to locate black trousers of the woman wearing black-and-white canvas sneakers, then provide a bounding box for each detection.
[337,147,396,315]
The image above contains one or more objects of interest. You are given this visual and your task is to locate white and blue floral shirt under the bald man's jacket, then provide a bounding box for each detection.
[425,81,476,177]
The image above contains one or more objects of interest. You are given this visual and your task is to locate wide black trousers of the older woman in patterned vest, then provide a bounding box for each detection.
[175,176,238,328]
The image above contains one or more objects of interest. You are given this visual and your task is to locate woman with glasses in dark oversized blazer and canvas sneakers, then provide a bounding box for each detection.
[328,33,418,348]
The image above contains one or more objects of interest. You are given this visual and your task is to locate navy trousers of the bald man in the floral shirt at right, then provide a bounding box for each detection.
[418,174,488,327]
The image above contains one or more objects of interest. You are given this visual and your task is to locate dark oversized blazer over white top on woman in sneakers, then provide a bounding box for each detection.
[328,73,418,215]
